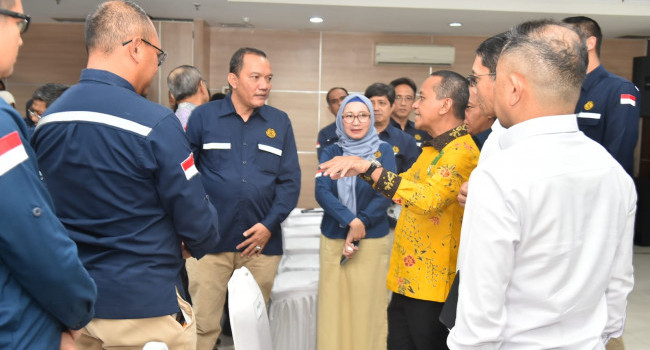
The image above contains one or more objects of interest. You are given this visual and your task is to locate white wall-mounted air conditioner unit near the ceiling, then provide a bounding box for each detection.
[375,44,456,65]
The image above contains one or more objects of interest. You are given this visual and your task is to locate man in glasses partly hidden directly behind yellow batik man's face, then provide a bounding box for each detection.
[390,77,431,147]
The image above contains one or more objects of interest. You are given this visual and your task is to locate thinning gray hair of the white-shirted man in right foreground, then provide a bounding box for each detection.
[501,20,588,103]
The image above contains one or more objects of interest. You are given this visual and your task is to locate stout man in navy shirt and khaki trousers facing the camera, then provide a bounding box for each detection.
[187,48,300,350]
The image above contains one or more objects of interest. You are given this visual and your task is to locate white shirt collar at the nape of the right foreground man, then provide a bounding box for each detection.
[499,114,578,149]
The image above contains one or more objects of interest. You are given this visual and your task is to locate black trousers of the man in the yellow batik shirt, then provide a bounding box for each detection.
[388,293,449,350]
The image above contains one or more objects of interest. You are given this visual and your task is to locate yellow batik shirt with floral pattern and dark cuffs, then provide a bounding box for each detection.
[375,125,479,302]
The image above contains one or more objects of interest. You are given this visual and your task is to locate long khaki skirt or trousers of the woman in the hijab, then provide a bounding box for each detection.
[317,236,390,350]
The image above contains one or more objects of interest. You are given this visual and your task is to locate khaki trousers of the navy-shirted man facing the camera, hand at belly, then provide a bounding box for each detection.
[185,253,282,350]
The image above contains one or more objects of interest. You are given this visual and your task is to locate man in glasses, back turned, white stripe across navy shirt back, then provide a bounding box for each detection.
[32,1,219,349]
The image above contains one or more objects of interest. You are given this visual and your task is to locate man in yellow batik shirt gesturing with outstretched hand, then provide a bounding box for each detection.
[320,71,479,350]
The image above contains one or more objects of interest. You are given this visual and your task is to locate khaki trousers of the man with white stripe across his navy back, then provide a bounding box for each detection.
[76,291,196,350]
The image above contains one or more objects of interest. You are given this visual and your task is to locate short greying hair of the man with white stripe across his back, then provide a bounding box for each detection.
[86,0,156,54]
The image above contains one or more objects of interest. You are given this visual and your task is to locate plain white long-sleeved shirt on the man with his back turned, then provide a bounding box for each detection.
[447,115,636,350]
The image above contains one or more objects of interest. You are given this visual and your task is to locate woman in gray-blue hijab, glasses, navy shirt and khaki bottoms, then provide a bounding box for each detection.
[316,94,395,350]
